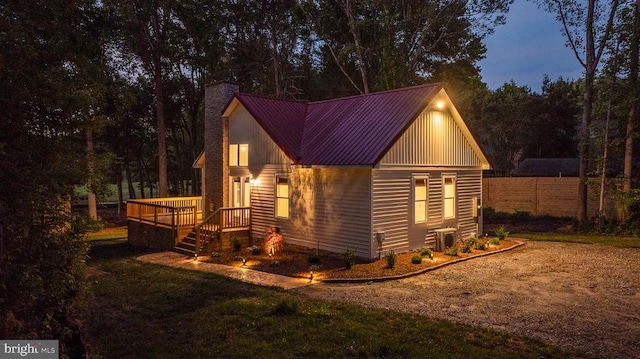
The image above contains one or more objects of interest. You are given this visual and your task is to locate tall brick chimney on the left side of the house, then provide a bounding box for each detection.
[203,81,239,216]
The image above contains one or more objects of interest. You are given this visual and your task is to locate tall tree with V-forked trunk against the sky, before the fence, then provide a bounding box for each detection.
[539,0,619,223]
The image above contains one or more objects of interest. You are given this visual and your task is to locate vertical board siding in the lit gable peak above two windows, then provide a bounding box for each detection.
[380,111,481,167]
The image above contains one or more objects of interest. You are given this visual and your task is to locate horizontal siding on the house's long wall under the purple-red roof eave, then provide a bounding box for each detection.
[246,165,371,258]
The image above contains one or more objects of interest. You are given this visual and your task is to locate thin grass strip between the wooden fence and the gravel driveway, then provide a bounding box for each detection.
[510,232,640,248]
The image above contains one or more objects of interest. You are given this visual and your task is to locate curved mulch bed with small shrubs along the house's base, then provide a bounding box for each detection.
[201,238,521,281]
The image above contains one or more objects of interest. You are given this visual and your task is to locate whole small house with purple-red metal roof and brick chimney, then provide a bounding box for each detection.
[196,82,489,259]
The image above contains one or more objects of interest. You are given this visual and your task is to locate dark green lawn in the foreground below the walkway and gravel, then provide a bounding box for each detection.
[85,241,584,358]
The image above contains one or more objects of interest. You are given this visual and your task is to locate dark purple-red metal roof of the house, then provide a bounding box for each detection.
[236,83,442,166]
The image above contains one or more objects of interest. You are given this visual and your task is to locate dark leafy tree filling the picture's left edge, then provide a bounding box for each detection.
[0,0,104,357]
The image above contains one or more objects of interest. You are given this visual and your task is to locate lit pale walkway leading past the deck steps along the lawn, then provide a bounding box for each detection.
[137,252,319,290]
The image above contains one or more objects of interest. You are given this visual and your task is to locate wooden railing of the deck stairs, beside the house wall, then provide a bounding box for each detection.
[195,207,251,258]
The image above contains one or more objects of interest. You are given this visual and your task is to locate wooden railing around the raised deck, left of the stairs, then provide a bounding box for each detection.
[127,197,202,230]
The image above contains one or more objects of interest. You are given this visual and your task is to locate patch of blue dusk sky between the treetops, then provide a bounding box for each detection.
[479,0,582,93]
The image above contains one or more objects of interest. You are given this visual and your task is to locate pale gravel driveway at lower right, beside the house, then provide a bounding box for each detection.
[297,241,640,358]
